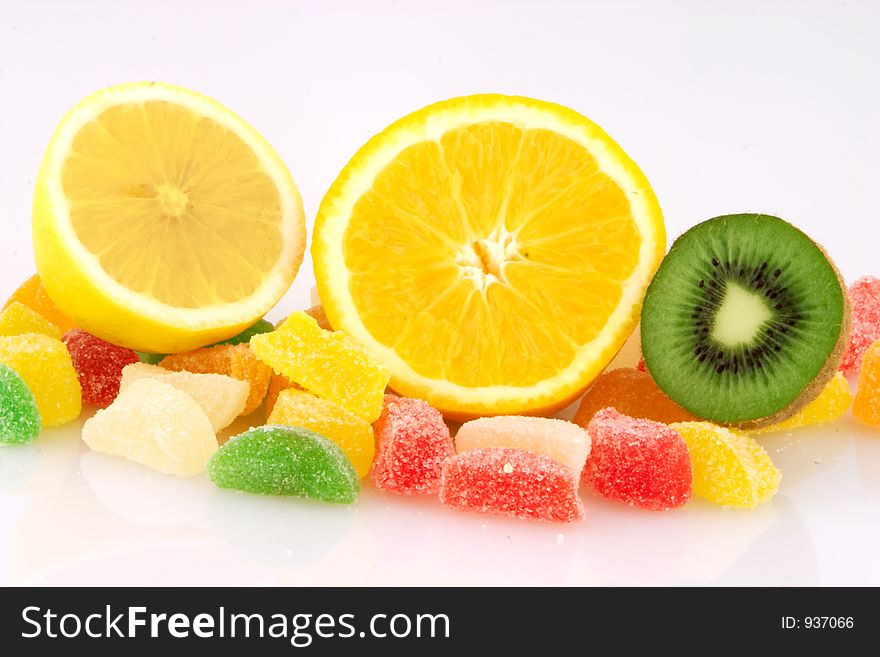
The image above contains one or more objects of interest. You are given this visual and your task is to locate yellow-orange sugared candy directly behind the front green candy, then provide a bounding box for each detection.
[266,389,376,477]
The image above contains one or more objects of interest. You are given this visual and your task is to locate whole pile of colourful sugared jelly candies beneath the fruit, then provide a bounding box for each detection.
[0,276,880,522]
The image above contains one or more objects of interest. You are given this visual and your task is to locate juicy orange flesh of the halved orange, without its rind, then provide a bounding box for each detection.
[343,122,641,387]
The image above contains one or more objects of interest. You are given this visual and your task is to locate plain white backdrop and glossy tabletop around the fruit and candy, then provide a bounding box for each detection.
[0,0,880,585]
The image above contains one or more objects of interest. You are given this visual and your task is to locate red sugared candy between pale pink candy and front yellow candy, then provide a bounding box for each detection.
[583,408,693,511]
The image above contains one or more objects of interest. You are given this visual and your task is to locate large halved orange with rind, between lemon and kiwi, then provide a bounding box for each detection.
[312,95,665,418]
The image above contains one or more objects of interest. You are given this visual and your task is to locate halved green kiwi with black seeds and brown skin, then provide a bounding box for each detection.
[641,214,849,428]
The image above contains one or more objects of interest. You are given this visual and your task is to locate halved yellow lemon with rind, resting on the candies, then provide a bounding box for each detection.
[33,82,305,353]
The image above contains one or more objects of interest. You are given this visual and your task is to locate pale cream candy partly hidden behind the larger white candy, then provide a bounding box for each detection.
[120,363,250,433]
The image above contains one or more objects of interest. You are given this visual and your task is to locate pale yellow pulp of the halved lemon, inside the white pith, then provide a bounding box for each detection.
[62,101,283,308]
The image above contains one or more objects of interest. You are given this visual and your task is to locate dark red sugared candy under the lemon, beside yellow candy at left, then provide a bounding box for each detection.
[62,329,140,408]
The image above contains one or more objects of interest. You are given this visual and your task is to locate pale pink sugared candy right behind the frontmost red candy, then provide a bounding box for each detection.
[455,415,590,476]
